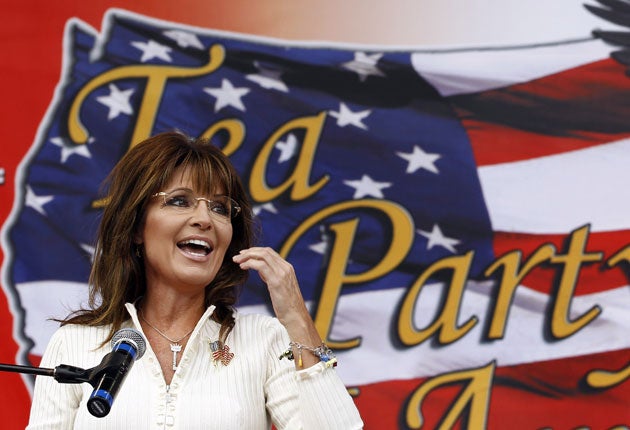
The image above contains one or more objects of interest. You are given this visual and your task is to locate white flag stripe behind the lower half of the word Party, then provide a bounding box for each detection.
[240,283,630,386]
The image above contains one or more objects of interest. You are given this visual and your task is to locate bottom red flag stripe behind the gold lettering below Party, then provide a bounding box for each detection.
[355,350,630,430]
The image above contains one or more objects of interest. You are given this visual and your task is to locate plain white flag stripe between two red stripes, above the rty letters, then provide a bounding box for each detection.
[479,139,630,234]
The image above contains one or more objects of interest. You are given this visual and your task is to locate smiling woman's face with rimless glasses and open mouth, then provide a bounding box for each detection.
[137,169,232,293]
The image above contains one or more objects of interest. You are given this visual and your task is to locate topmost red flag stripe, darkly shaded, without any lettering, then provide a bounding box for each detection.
[449,59,630,166]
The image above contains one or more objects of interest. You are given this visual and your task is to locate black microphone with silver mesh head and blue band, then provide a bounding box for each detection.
[87,328,146,418]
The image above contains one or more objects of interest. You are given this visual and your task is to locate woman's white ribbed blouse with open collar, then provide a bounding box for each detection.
[27,304,363,430]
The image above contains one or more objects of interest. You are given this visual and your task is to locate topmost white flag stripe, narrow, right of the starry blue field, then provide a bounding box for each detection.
[411,40,611,96]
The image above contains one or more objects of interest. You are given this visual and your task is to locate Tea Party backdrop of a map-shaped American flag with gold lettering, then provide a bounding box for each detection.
[1,3,630,429]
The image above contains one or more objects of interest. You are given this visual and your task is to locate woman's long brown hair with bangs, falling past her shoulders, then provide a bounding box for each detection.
[61,132,253,342]
